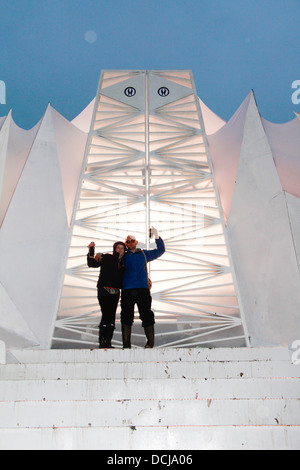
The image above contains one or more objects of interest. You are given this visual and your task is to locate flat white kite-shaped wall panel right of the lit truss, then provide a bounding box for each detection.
[228,95,300,345]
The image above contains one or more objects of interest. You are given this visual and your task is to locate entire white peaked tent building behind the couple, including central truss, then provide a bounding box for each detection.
[0,71,300,349]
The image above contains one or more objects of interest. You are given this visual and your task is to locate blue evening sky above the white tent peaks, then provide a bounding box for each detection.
[0,0,300,129]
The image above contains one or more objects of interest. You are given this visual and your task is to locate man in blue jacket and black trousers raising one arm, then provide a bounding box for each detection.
[121,228,165,349]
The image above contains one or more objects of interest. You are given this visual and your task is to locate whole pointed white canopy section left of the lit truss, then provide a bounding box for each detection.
[0,106,86,347]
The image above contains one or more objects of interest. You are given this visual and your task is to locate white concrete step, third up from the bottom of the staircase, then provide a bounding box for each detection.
[0,378,300,401]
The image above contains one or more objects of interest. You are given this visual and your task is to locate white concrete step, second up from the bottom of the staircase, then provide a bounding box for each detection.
[0,399,300,428]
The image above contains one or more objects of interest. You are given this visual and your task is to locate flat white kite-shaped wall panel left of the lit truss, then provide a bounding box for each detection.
[0,107,68,347]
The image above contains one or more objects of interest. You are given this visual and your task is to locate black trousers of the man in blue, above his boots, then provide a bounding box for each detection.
[121,289,155,328]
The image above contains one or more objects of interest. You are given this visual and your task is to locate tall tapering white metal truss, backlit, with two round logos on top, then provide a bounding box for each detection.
[53,71,248,347]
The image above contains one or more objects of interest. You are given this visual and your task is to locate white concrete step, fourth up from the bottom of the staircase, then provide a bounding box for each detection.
[0,361,300,381]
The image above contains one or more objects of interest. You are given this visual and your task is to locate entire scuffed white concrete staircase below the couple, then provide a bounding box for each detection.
[0,348,300,450]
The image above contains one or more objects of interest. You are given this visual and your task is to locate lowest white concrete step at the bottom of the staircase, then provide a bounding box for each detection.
[0,426,300,450]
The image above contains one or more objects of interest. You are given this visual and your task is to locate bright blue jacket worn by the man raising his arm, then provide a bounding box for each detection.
[123,238,165,290]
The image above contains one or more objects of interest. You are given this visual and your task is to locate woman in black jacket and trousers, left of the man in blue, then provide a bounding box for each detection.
[87,242,126,349]
